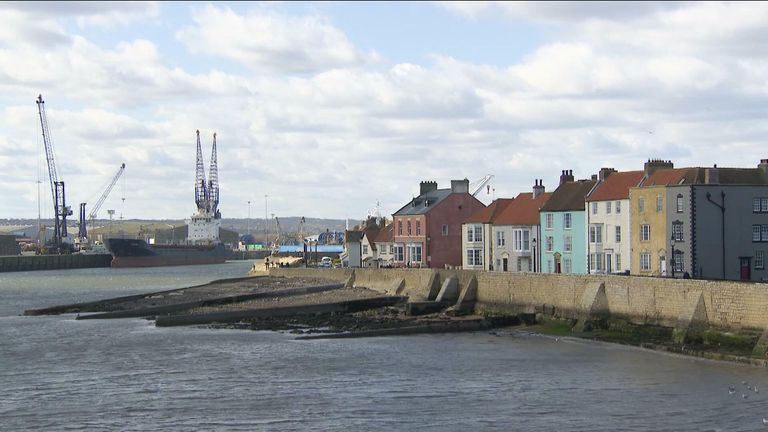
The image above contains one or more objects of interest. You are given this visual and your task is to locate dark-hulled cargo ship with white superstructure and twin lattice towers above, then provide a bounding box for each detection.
[107,131,232,267]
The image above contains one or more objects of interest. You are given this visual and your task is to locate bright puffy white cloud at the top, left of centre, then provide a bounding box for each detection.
[176,5,377,73]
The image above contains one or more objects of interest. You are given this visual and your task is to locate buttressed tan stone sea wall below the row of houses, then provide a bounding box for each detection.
[270,268,768,330]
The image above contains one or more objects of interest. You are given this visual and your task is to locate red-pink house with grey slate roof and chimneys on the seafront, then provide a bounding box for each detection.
[392,179,485,268]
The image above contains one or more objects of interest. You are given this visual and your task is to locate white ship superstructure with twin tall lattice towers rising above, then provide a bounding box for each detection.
[187,130,221,244]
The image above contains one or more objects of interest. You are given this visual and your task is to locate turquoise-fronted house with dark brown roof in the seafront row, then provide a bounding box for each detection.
[537,170,597,274]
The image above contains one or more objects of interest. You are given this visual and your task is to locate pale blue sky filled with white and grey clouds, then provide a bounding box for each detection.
[0,2,768,219]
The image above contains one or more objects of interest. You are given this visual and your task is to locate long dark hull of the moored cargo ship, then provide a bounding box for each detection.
[107,239,231,267]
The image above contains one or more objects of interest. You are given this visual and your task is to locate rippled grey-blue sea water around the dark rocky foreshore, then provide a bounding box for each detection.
[0,262,768,432]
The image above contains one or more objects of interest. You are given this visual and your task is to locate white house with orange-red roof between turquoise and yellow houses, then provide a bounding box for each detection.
[585,168,644,274]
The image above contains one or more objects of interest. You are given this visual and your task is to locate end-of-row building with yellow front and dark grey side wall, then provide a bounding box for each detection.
[630,159,768,280]
